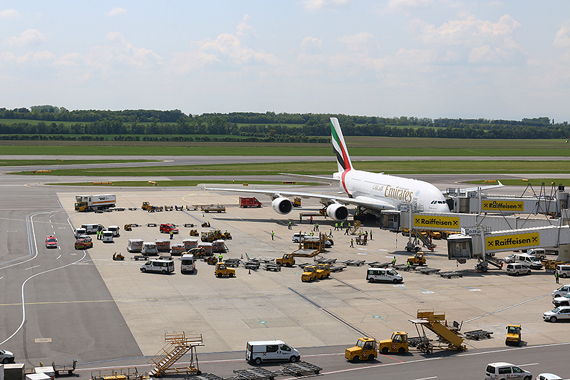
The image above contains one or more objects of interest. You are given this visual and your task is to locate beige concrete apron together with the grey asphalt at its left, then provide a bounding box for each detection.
[0,171,568,372]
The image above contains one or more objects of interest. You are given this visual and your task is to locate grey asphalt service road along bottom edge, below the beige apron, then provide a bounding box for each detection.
[69,344,570,380]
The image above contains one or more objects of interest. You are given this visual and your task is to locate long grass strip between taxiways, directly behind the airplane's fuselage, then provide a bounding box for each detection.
[13,161,569,177]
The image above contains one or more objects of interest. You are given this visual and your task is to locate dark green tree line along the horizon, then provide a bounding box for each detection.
[0,106,570,142]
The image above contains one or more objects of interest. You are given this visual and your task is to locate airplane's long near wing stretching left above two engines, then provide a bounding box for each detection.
[204,186,395,211]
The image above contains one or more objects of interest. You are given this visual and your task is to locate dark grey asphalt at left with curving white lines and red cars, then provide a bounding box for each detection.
[0,183,140,366]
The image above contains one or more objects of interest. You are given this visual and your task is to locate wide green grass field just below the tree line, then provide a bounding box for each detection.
[0,136,570,157]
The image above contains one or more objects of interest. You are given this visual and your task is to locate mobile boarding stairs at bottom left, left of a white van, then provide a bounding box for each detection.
[148,331,204,377]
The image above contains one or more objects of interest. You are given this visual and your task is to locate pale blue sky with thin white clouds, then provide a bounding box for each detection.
[0,0,570,122]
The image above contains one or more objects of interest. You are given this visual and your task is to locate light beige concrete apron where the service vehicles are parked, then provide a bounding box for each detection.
[58,188,567,355]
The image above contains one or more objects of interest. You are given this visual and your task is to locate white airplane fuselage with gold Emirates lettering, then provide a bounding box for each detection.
[340,169,450,212]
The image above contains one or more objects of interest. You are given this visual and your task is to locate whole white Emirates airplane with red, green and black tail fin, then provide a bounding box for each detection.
[206,117,462,221]
